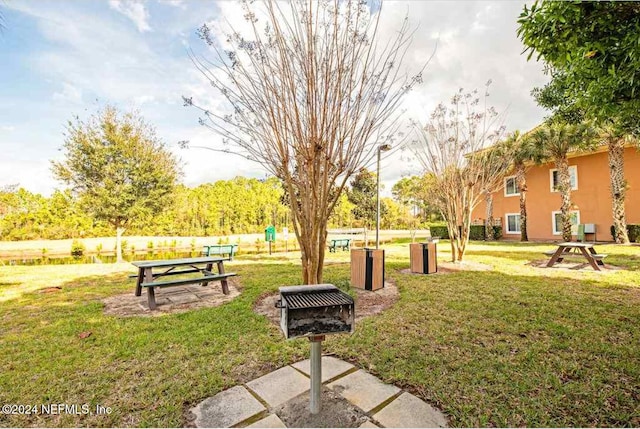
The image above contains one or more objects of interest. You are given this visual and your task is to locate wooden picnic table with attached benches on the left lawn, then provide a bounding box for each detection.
[132,256,236,310]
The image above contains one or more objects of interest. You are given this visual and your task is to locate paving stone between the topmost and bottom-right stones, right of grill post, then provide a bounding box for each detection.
[329,370,400,413]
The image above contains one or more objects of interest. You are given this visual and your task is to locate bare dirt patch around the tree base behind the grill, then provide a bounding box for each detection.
[253,280,399,326]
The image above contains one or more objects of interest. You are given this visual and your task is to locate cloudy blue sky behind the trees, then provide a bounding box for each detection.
[0,0,546,195]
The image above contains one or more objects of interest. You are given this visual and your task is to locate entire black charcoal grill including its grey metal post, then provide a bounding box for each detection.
[276,284,356,414]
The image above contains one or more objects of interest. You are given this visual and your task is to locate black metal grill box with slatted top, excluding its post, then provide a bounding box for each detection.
[276,284,355,339]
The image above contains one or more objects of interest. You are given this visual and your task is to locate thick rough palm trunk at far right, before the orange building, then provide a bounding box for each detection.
[609,138,629,244]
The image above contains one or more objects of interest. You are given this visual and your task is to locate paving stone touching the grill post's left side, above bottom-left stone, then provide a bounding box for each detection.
[247,366,310,407]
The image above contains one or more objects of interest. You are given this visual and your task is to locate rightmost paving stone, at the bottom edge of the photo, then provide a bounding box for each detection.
[373,392,447,428]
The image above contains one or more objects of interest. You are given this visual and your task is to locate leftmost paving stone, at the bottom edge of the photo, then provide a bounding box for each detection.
[191,386,266,428]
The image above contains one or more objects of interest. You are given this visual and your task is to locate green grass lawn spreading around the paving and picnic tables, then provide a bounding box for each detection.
[0,242,640,427]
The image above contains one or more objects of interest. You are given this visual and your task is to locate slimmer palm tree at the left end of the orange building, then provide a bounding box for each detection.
[505,130,542,241]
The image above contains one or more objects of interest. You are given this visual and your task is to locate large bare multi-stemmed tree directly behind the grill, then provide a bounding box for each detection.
[185,0,421,284]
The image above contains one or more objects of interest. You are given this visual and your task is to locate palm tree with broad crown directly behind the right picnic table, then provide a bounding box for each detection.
[531,122,597,241]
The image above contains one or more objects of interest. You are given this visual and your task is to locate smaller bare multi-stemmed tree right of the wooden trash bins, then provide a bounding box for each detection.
[412,81,511,262]
